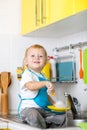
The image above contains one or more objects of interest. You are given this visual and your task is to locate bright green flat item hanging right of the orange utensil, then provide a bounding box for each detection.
[83,48,87,84]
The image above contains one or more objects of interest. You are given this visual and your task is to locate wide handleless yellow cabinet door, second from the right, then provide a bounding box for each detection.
[50,0,75,22]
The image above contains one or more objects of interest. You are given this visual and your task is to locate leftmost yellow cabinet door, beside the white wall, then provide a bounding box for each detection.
[22,0,36,34]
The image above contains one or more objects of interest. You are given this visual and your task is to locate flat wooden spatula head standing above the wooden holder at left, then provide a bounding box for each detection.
[1,72,11,93]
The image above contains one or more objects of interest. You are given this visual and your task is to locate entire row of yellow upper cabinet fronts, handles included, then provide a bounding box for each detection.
[22,0,87,35]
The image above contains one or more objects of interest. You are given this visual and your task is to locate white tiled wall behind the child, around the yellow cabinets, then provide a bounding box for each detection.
[0,0,87,113]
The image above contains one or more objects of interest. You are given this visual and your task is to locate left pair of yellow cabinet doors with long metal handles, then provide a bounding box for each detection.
[22,0,50,34]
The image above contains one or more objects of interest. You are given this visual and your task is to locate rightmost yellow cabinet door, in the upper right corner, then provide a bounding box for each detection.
[74,0,87,13]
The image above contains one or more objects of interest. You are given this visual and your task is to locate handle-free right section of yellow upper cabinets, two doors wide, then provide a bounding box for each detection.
[47,0,87,23]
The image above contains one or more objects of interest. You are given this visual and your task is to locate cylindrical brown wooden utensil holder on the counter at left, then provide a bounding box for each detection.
[1,93,8,116]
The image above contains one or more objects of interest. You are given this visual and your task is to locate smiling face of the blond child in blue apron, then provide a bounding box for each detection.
[26,48,47,72]
